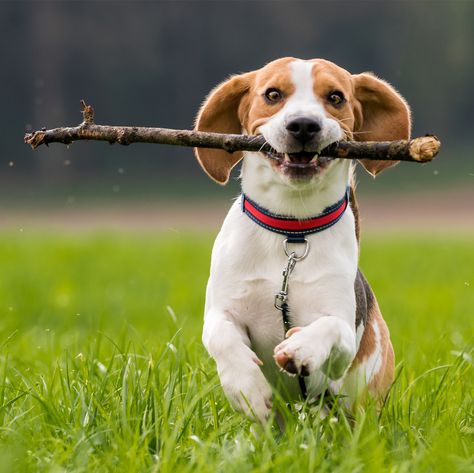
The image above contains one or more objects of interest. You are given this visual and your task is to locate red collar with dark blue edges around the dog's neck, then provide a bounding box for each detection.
[242,188,349,242]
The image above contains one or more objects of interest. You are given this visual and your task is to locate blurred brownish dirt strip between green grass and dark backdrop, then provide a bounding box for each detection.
[0,189,474,233]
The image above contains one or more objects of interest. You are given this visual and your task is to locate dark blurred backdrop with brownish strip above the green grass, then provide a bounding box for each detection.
[0,0,474,231]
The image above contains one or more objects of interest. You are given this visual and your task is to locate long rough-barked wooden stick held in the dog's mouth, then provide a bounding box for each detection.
[24,100,441,163]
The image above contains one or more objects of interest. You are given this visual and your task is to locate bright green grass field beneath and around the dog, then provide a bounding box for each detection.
[0,232,474,473]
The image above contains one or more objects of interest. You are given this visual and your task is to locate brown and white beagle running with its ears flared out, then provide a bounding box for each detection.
[195,58,410,422]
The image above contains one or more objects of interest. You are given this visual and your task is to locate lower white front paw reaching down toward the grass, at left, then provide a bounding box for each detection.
[219,363,272,423]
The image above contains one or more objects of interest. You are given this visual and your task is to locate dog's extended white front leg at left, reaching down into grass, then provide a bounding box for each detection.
[202,310,272,423]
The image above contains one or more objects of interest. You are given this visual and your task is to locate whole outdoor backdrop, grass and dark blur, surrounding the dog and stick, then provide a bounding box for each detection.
[0,5,474,466]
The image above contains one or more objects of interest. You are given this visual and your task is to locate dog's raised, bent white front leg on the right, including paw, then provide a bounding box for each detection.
[274,316,356,380]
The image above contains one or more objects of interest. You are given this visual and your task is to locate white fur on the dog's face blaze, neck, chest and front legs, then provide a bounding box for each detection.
[203,61,358,421]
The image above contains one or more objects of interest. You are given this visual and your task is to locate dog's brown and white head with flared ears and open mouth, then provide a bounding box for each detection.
[196,58,410,184]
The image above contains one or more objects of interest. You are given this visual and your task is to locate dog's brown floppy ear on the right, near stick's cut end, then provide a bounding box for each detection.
[352,73,411,176]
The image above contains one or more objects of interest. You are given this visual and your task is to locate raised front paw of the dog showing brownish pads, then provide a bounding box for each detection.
[273,327,331,376]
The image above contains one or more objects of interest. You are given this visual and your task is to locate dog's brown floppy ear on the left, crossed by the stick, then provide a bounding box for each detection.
[194,72,255,184]
